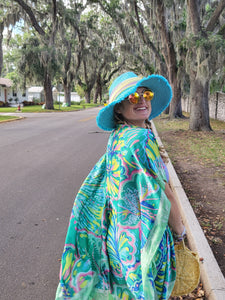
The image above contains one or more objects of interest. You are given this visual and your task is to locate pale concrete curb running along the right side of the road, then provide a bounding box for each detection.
[152,122,225,300]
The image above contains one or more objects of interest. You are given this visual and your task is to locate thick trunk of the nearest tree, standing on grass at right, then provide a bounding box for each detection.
[186,0,212,131]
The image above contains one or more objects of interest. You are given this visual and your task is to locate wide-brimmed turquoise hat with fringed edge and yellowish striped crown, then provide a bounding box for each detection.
[96,72,172,131]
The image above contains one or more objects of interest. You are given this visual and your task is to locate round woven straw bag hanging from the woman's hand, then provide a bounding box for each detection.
[171,240,200,296]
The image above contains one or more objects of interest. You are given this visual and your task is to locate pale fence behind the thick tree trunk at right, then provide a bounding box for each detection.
[182,92,225,122]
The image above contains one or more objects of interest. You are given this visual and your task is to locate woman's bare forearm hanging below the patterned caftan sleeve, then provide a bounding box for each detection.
[164,183,184,235]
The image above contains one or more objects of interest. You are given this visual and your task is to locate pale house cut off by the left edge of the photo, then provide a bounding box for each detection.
[0,78,27,106]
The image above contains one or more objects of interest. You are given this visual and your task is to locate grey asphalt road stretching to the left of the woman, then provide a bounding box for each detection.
[0,108,109,300]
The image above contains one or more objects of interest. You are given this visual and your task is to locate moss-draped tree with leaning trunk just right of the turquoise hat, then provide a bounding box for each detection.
[88,0,185,118]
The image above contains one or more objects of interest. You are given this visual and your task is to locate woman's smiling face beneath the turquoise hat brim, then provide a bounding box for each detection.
[116,87,152,128]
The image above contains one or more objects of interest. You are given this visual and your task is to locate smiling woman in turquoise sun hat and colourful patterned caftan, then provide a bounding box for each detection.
[56,72,185,300]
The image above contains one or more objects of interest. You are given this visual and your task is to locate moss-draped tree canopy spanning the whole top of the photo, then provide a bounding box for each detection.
[0,0,225,130]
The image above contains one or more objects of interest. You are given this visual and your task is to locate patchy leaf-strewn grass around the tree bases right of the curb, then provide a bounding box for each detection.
[154,114,225,167]
